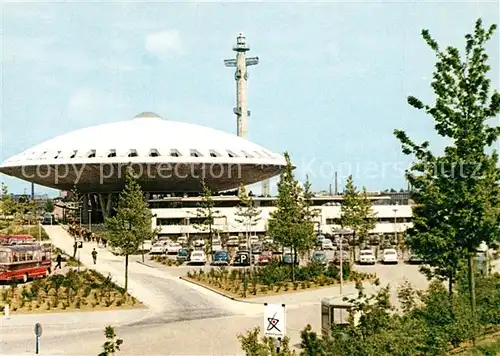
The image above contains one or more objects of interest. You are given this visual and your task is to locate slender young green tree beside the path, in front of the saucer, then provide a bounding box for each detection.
[105,167,156,290]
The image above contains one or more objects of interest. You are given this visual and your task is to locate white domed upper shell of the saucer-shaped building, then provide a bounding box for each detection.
[0,112,284,167]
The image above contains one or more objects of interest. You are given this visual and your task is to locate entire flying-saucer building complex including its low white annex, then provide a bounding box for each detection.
[0,112,411,235]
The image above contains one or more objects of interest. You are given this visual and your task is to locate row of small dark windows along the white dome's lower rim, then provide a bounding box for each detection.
[27,148,274,159]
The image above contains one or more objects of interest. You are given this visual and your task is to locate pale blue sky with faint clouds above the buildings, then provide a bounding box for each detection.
[1,1,499,192]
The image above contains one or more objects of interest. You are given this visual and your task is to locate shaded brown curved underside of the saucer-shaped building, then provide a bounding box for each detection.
[0,163,283,193]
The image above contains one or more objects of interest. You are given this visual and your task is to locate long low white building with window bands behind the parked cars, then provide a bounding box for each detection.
[149,194,412,241]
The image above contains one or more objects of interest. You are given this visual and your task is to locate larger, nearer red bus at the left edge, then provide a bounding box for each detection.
[0,244,52,282]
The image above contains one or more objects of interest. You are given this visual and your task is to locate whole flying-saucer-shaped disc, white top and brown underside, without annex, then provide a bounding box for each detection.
[0,112,285,193]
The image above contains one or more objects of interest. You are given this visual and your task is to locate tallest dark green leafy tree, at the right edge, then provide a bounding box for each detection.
[394,19,500,342]
